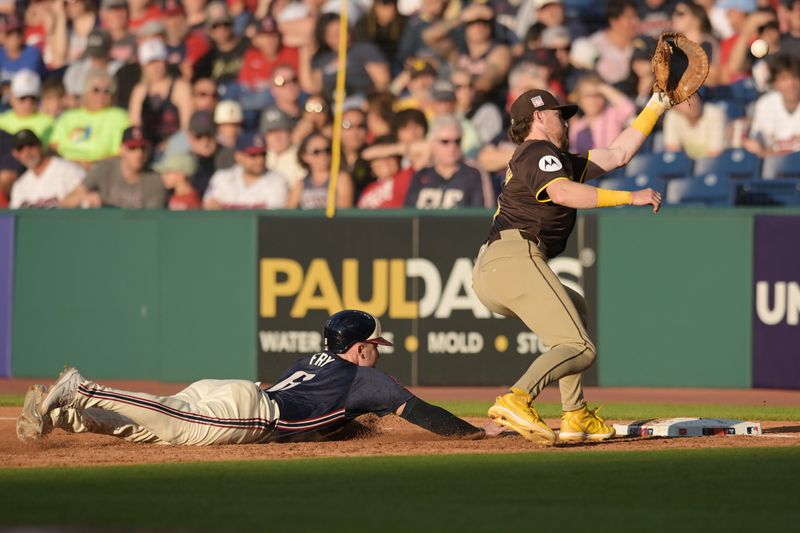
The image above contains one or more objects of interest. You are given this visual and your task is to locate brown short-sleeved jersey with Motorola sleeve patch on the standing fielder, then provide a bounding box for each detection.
[489,140,589,258]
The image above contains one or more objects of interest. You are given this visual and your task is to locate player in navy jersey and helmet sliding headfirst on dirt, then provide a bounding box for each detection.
[17,310,485,446]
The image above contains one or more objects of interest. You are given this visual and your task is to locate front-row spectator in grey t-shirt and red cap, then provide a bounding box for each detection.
[62,126,166,209]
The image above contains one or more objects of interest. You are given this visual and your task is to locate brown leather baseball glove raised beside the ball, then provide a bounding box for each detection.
[652,32,708,106]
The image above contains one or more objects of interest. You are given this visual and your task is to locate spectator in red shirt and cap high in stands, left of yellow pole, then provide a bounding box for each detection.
[239,17,299,91]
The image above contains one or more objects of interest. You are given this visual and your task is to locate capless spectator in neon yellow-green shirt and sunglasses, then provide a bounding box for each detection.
[50,70,130,167]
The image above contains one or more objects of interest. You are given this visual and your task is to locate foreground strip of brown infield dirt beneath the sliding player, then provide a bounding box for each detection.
[0,407,800,467]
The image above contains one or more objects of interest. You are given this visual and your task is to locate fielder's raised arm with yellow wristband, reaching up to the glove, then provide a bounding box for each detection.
[585,93,671,180]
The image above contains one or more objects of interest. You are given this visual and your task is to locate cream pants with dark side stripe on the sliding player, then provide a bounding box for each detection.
[60,379,280,446]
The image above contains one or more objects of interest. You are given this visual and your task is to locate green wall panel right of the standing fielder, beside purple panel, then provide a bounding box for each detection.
[598,209,753,387]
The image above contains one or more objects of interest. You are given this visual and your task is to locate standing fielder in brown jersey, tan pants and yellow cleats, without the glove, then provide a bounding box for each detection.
[472,90,669,444]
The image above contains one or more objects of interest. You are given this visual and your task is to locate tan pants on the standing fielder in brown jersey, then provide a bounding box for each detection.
[472,230,595,411]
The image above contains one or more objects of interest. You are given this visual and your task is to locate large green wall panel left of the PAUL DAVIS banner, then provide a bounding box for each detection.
[12,210,256,381]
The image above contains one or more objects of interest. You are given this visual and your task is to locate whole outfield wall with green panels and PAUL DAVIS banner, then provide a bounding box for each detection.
[0,208,800,387]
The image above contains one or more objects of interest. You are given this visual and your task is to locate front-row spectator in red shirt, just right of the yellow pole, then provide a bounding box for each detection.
[358,135,414,209]
